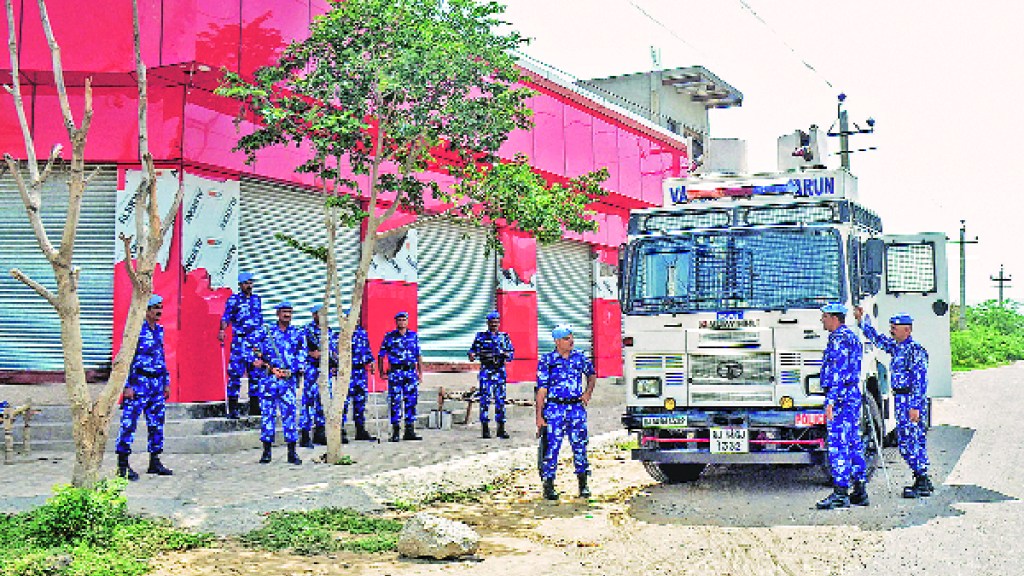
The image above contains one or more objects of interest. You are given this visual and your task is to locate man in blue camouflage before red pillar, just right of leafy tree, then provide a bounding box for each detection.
[377,312,423,442]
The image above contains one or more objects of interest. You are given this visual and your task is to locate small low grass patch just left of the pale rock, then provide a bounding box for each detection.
[240,508,401,556]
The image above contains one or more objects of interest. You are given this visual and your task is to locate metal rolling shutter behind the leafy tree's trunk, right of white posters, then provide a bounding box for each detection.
[239,177,359,325]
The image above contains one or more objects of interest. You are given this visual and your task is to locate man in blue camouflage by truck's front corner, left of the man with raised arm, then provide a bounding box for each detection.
[816,302,868,509]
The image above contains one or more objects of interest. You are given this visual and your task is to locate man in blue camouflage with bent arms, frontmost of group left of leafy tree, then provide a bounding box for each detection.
[249,301,306,464]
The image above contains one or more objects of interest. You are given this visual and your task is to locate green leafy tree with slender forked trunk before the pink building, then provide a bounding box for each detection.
[218,0,607,462]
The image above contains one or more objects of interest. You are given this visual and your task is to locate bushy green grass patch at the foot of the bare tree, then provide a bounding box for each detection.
[0,479,213,576]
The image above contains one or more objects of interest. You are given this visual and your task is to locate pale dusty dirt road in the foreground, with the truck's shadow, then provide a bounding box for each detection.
[146,365,1024,576]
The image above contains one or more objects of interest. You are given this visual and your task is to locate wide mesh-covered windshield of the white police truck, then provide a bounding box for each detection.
[623,228,844,315]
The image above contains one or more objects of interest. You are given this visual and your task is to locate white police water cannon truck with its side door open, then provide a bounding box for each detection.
[620,155,951,483]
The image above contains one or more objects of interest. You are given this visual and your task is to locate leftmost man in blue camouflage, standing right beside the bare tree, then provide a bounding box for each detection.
[117,294,173,481]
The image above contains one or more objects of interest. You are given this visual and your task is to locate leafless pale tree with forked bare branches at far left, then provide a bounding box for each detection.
[4,0,182,487]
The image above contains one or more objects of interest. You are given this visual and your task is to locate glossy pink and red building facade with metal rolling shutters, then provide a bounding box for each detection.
[0,0,689,402]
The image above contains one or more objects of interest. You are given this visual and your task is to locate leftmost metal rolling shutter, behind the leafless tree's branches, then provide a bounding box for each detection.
[0,161,118,371]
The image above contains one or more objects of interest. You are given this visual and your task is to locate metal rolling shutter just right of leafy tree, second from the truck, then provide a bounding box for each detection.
[417,220,497,362]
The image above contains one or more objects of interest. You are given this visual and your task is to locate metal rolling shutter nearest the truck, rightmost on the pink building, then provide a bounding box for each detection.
[537,241,594,355]
